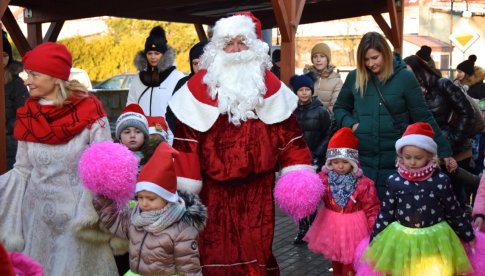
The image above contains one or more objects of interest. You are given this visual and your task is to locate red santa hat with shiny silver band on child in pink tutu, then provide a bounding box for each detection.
[325,127,359,173]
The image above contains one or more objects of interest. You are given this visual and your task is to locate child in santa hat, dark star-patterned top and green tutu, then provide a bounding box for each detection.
[363,122,475,275]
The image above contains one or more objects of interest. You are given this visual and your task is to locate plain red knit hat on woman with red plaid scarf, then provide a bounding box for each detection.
[22,42,72,81]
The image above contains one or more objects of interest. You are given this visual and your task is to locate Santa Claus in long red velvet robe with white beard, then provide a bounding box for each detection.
[169,13,323,275]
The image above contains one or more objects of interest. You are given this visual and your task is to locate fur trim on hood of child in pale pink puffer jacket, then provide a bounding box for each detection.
[177,190,207,232]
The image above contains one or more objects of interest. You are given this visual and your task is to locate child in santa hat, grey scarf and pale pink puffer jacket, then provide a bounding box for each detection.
[93,143,207,275]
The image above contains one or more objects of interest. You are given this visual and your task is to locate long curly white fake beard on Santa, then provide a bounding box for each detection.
[203,50,266,126]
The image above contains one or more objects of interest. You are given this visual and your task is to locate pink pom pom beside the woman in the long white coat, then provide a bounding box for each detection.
[78,141,139,206]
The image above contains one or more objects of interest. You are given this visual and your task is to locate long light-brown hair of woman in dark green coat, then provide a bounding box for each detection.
[355,32,394,97]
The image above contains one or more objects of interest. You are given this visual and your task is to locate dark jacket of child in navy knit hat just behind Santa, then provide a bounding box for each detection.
[295,97,331,168]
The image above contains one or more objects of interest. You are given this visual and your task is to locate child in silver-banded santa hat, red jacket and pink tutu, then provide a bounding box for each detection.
[304,127,380,275]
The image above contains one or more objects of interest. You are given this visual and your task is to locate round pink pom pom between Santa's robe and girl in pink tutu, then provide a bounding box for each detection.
[274,170,325,221]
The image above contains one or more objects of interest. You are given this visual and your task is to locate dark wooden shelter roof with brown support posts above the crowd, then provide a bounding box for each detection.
[0,0,404,172]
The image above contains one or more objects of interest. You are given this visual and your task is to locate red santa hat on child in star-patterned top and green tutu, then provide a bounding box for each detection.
[396,122,438,156]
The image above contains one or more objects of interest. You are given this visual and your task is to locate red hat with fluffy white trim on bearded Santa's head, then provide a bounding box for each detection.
[211,12,262,42]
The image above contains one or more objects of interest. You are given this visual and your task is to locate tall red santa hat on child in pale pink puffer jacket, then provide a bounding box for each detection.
[135,142,179,202]
